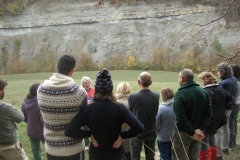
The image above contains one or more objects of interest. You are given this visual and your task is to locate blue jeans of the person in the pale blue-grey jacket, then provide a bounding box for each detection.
[157,140,172,160]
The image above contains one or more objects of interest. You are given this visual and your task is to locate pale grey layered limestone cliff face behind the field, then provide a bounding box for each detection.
[0,0,240,61]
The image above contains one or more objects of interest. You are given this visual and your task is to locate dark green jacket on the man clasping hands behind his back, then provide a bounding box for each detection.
[173,81,213,136]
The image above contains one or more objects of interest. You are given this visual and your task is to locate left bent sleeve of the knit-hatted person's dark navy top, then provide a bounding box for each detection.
[64,107,91,138]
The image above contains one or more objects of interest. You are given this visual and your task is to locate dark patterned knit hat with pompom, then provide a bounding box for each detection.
[95,68,113,93]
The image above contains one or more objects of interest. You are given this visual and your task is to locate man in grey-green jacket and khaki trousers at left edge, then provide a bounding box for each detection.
[0,77,28,160]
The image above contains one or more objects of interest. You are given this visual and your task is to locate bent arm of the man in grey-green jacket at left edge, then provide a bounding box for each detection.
[8,105,24,123]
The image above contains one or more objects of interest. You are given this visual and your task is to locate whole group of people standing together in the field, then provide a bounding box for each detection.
[0,55,240,160]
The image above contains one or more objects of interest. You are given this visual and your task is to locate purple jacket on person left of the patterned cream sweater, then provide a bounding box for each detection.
[22,97,44,138]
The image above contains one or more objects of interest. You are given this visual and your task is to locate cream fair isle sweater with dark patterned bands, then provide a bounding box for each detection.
[37,73,87,156]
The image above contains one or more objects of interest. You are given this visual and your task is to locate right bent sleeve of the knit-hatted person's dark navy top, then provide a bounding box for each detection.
[120,107,144,139]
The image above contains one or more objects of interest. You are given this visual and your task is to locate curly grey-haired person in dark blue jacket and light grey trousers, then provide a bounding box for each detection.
[216,62,237,157]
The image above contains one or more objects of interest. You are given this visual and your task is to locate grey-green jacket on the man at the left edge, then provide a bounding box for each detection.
[0,101,24,145]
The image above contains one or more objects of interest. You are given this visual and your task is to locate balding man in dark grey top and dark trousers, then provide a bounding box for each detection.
[128,72,160,160]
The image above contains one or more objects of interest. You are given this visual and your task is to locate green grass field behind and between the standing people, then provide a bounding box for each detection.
[1,70,240,160]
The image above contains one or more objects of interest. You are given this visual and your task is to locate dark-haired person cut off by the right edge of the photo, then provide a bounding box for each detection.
[228,64,240,148]
